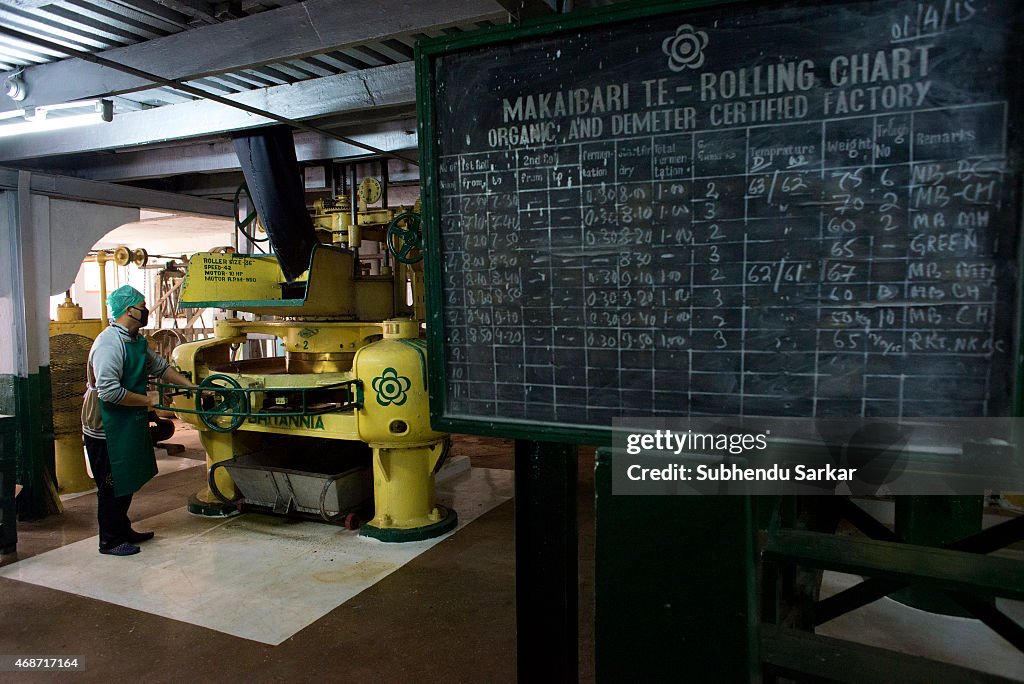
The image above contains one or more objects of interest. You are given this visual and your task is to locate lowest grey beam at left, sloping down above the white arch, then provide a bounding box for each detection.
[0,168,234,217]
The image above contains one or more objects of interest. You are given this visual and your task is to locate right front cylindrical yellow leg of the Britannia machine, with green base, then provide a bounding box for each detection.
[360,441,459,542]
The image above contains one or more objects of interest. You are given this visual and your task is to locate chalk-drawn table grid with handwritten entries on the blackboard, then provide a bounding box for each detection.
[440,102,1010,422]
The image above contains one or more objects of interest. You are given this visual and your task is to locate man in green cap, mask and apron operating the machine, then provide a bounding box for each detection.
[82,285,195,556]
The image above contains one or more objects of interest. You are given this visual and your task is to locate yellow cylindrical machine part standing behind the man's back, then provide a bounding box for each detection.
[50,293,102,494]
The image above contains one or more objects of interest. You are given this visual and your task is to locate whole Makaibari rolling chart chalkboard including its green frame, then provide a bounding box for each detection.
[417,0,1024,441]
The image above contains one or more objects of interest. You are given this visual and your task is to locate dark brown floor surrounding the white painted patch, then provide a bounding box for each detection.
[0,426,593,682]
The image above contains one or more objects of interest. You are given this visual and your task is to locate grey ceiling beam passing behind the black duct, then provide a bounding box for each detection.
[51,120,417,181]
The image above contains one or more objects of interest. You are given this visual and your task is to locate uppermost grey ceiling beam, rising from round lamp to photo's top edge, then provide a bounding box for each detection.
[0,0,505,112]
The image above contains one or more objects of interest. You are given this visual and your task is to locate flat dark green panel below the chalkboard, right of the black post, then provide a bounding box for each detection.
[594,448,760,682]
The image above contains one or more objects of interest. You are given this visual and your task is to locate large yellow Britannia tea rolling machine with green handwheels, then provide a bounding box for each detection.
[165,189,457,542]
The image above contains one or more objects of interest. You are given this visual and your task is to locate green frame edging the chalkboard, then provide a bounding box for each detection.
[416,0,756,445]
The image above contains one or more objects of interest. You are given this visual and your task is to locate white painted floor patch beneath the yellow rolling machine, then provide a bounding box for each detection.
[0,468,512,645]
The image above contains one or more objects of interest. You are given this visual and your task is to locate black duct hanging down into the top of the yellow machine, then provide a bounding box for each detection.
[233,126,316,282]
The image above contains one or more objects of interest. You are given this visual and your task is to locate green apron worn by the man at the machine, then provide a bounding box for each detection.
[99,336,157,497]
